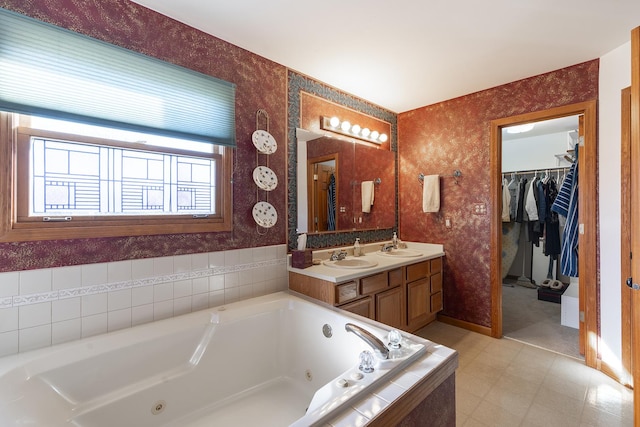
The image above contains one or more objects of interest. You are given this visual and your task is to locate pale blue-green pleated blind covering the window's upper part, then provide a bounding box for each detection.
[0,8,235,146]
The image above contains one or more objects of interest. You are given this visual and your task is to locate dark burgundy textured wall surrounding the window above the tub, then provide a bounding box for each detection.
[0,0,287,271]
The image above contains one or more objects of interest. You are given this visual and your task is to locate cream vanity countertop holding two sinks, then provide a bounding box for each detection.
[287,242,445,283]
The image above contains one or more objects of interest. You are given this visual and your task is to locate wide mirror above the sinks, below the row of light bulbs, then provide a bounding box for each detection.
[297,134,395,233]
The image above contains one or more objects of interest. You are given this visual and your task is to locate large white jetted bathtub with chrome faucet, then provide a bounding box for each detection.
[0,292,448,427]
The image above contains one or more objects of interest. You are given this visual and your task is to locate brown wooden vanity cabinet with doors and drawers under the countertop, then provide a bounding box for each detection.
[289,258,442,332]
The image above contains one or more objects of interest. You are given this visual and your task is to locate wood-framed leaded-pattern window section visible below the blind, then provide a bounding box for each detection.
[0,113,231,241]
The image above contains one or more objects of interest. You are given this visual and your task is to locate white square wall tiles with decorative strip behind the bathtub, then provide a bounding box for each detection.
[0,244,288,357]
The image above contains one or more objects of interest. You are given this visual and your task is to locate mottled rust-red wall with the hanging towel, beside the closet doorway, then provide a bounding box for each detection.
[398,60,599,327]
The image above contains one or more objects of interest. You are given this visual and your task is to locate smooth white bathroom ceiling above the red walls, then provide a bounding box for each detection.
[134,0,640,113]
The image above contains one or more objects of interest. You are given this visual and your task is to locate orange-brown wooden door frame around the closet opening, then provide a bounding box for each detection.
[489,100,599,368]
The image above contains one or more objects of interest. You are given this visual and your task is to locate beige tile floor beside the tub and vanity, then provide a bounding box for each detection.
[417,322,633,427]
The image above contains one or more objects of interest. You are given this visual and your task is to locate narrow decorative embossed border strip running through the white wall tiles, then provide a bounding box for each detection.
[0,258,287,309]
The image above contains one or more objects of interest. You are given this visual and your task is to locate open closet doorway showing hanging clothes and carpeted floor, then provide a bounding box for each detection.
[501,115,583,359]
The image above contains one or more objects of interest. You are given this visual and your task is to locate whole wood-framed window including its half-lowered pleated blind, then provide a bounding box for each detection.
[0,8,236,241]
